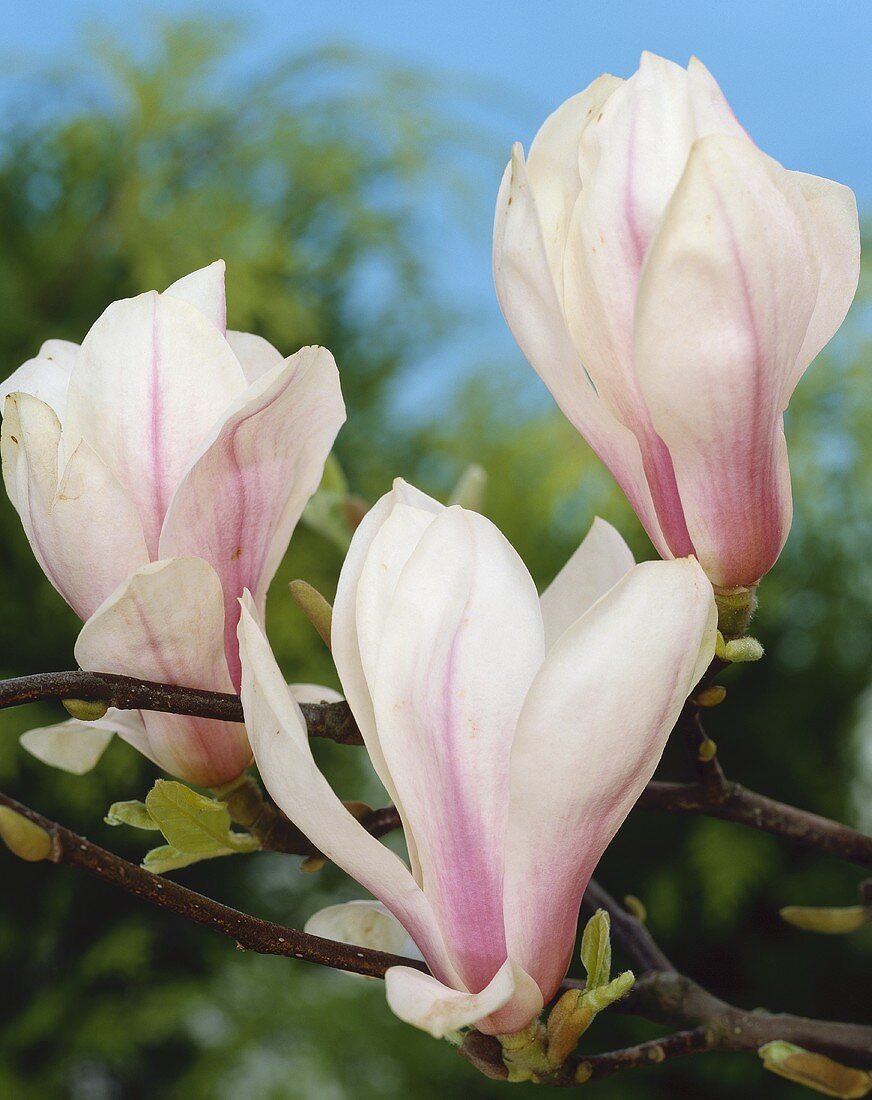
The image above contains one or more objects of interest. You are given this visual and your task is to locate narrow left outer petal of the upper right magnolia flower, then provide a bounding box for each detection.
[494,145,672,558]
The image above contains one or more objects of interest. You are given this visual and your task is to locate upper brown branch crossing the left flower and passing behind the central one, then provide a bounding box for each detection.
[0,671,872,867]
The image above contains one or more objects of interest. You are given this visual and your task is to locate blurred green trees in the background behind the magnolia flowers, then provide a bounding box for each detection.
[0,22,872,1100]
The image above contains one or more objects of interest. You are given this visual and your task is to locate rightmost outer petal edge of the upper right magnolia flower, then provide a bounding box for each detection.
[782,172,860,398]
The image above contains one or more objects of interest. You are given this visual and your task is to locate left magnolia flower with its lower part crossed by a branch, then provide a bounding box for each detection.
[0,261,344,785]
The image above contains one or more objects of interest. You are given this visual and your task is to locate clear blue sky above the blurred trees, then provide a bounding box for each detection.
[0,0,872,413]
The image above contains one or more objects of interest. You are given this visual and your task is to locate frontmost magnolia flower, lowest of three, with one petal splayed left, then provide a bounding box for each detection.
[240,482,716,1036]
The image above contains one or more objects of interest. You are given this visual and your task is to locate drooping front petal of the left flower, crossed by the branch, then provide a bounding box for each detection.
[76,558,251,787]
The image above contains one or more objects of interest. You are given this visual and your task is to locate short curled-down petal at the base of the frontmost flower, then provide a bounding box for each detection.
[385,959,542,1038]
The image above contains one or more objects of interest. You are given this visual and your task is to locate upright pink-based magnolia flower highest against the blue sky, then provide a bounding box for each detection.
[494,54,860,590]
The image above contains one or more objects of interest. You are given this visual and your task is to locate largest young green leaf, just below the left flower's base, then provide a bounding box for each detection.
[145,779,258,856]
